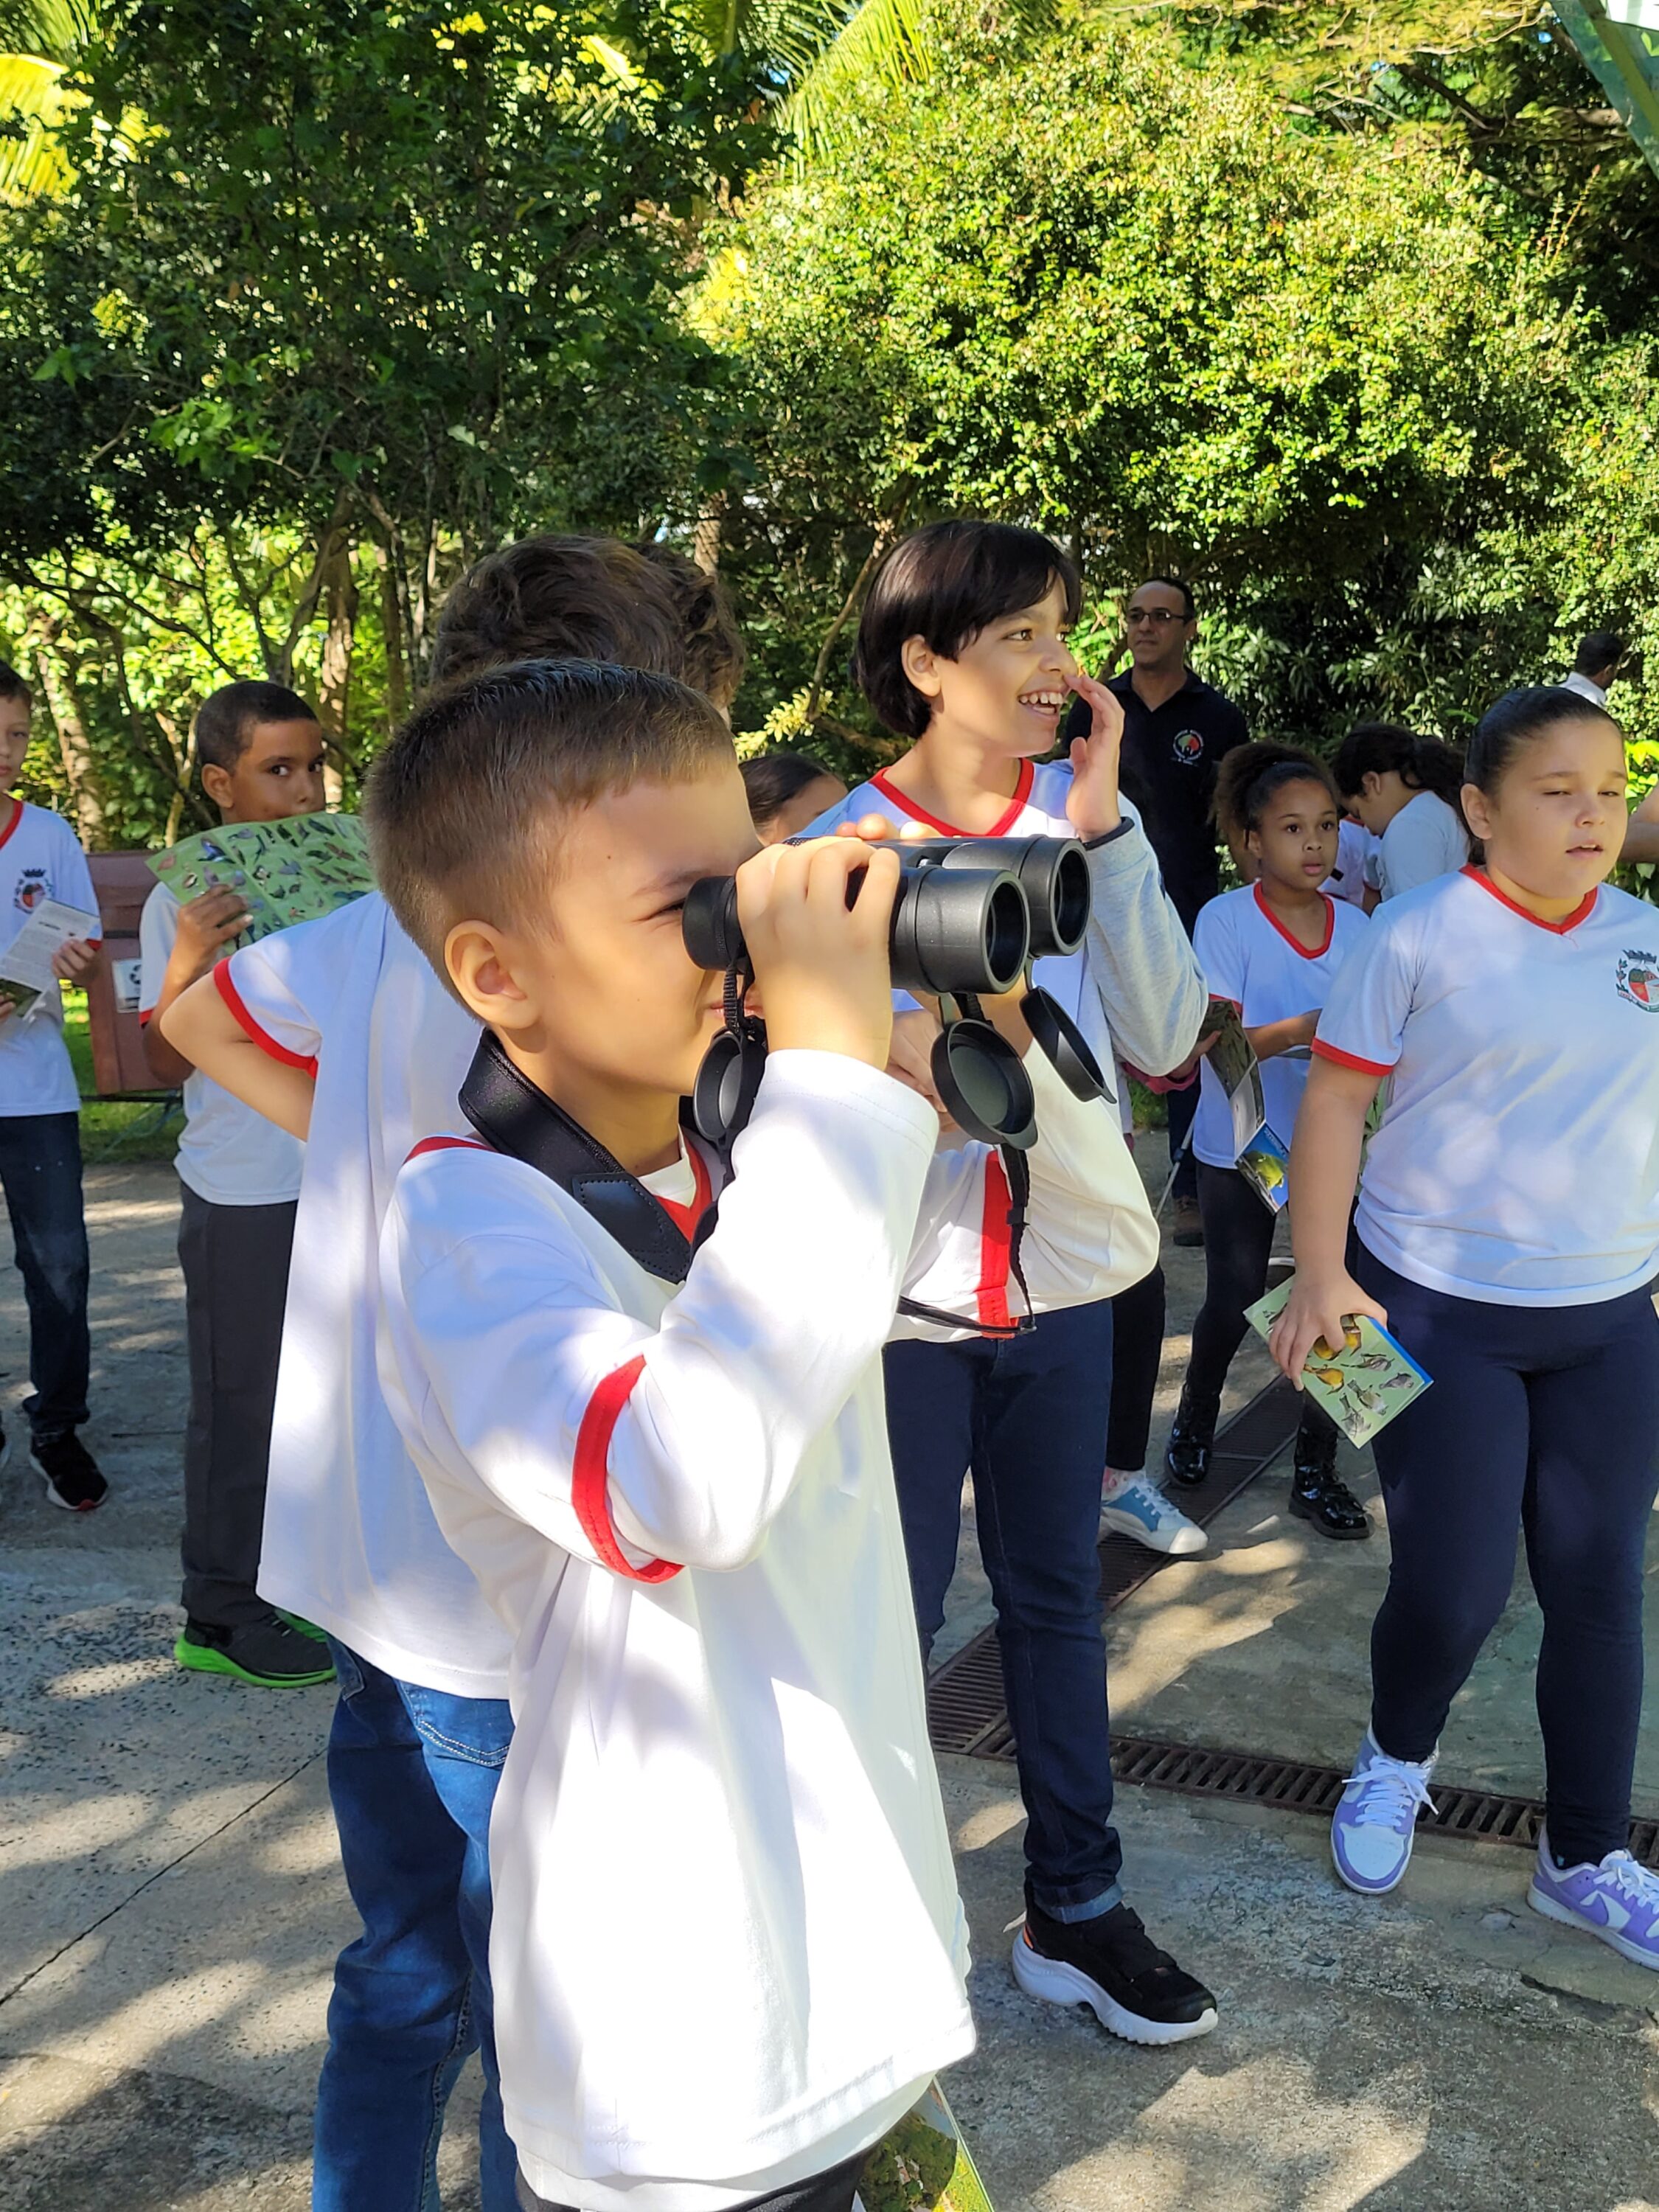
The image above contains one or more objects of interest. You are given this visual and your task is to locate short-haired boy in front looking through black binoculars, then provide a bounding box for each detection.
[369,664,1141,2212]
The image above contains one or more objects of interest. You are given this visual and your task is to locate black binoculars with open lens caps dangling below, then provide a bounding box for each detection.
[681,836,1106,1150]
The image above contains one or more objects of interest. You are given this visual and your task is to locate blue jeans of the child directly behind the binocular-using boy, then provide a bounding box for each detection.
[312,1637,518,2212]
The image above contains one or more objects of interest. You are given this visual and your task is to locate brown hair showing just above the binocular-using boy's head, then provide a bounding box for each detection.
[431,535,690,684]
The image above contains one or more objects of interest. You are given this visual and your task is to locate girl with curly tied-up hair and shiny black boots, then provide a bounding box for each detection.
[1166,743,1371,1542]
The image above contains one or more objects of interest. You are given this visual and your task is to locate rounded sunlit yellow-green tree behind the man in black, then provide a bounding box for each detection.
[710,8,1610,757]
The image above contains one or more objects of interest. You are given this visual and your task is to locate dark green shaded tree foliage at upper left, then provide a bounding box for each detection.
[0,0,768,841]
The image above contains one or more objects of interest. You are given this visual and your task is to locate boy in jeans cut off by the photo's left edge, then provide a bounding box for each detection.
[0,661,108,1513]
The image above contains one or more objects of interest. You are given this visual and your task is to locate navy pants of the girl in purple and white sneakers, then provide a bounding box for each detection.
[1356,1248,1659,1865]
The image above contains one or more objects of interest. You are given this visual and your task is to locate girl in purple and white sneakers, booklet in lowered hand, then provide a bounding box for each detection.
[1272,688,1659,1969]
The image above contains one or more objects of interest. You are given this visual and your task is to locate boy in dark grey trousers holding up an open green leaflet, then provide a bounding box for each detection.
[139,681,334,1690]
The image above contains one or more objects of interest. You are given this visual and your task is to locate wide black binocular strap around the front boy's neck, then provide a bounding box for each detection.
[460,1029,692,1283]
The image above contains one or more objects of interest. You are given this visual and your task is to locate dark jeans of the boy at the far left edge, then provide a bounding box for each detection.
[0,1113,93,1436]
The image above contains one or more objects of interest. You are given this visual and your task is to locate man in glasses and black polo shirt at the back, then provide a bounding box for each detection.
[1066,575,1248,1245]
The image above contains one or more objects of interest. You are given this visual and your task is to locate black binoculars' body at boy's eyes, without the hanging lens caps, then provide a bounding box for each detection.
[681,836,1088,998]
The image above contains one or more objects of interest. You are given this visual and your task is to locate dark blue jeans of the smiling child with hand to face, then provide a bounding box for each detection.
[887,1305,1124,1920]
